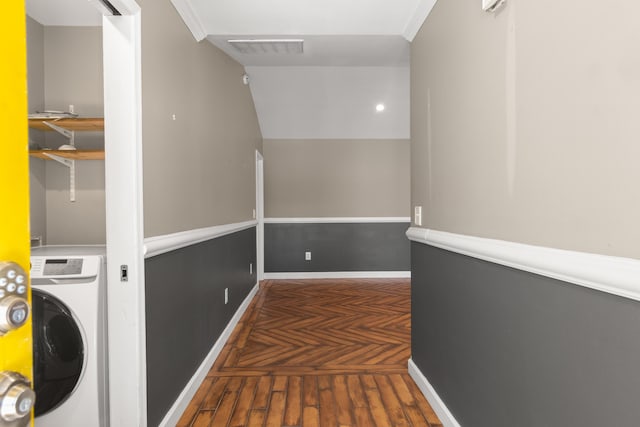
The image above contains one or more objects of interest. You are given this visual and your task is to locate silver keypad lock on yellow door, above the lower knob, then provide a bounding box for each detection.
[0,261,29,335]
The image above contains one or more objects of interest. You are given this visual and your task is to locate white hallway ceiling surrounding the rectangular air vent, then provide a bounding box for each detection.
[172,0,436,66]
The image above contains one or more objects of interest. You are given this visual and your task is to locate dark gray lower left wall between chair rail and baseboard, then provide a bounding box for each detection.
[145,228,257,426]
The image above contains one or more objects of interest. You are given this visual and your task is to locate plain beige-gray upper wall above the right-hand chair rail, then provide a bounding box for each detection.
[411,0,640,258]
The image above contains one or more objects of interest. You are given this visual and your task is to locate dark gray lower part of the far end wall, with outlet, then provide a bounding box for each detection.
[264,223,410,273]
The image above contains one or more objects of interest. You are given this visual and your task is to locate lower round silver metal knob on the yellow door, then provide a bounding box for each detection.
[0,372,36,426]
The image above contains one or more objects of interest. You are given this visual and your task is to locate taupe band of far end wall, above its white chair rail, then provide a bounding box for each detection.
[264,139,410,218]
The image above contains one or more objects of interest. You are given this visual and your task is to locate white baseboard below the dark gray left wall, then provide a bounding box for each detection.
[160,283,259,427]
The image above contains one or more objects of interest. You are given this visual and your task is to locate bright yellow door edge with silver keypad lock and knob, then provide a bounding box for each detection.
[0,0,33,427]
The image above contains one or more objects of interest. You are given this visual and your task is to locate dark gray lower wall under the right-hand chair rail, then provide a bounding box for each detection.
[411,243,640,427]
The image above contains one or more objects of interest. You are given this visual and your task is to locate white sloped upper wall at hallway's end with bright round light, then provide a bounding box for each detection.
[246,67,410,139]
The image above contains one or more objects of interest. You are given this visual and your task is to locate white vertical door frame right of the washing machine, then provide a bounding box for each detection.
[102,0,147,427]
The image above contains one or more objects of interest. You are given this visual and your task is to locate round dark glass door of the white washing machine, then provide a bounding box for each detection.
[32,288,84,417]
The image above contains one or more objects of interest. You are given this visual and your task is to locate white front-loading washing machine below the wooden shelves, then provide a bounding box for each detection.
[31,246,109,427]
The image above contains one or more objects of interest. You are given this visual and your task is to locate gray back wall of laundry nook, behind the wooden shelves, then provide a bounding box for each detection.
[44,27,106,245]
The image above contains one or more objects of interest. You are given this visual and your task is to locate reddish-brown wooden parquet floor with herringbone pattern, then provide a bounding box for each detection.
[178,279,442,427]
